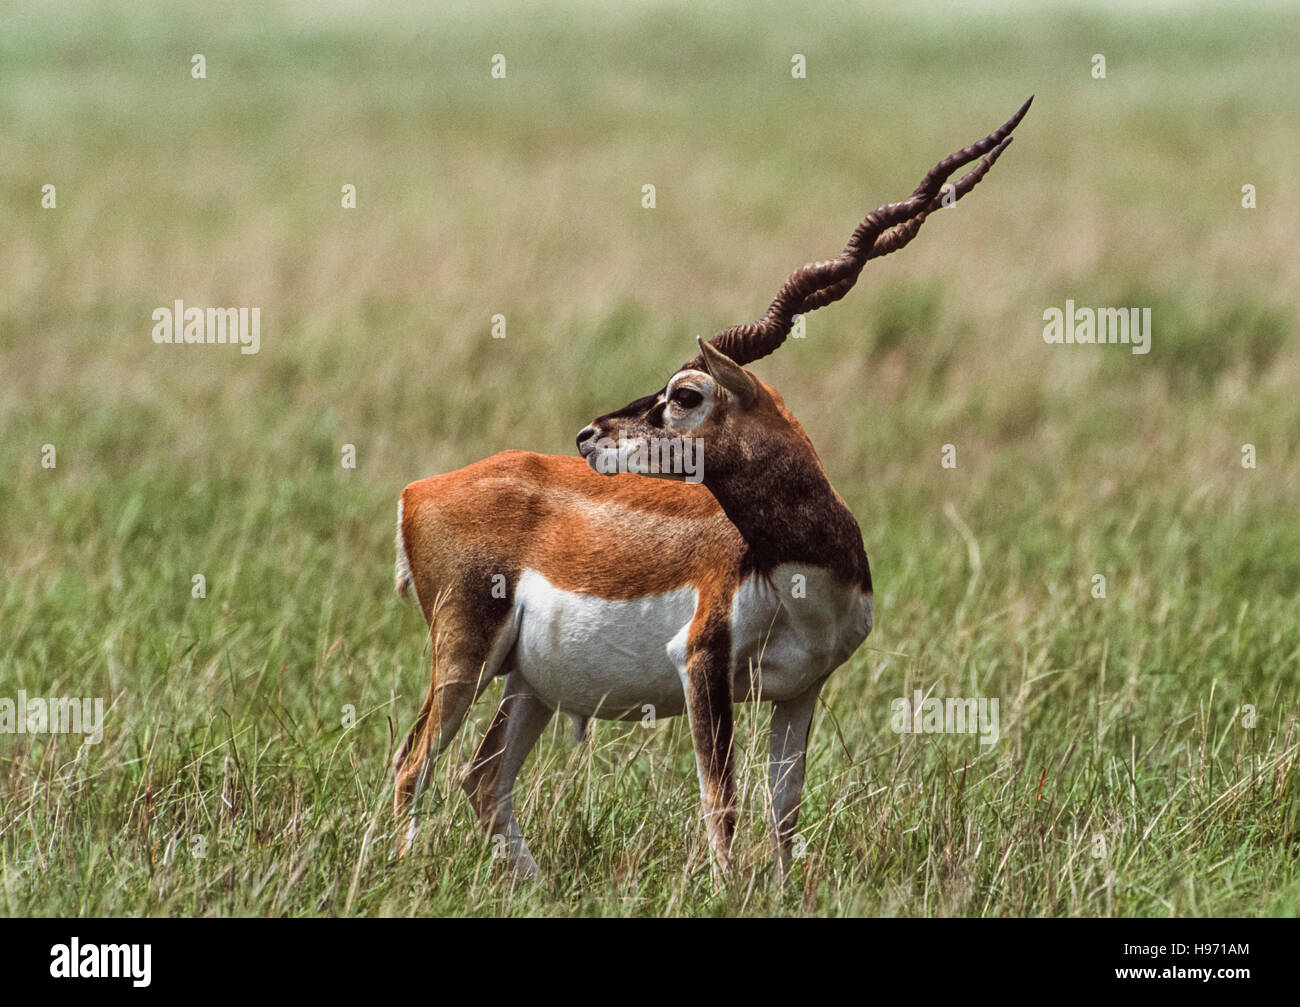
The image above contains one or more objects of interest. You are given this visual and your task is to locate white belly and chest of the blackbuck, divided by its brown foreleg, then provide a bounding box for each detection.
[514,567,871,719]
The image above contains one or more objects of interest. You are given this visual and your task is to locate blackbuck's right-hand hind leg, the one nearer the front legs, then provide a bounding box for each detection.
[462,672,554,877]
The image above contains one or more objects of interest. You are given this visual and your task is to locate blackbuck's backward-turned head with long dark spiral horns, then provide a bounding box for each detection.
[577,97,1034,482]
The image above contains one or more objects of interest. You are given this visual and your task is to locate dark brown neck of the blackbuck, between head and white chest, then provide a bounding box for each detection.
[705,455,871,591]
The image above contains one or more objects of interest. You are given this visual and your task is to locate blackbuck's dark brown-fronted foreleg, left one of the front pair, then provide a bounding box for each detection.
[683,620,736,874]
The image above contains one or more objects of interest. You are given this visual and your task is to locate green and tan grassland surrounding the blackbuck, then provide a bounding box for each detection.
[0,3,1300,916]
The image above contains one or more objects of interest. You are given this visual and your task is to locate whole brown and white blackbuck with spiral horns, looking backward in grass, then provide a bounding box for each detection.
[394,99,1032,881]
